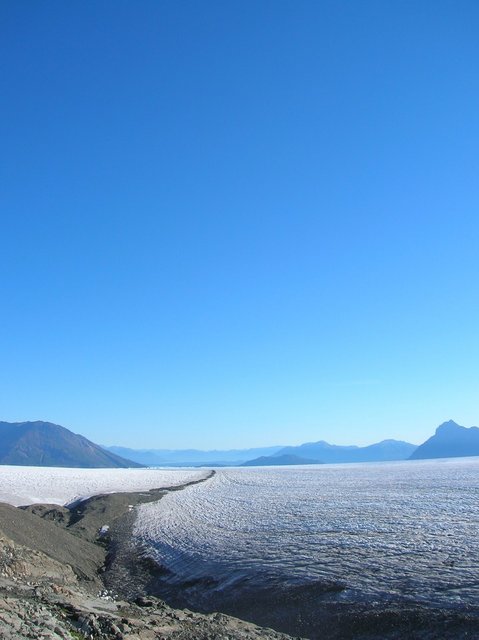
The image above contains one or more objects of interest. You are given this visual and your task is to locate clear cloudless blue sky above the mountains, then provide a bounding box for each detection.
[0,0,479,448]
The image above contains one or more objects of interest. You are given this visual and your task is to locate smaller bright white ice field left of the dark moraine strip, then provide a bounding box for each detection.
[0,465,209,507]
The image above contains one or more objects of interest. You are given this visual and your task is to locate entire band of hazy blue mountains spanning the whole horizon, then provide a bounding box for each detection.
[0,420,479,468]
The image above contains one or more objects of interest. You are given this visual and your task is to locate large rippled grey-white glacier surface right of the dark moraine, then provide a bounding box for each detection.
[135,458,479,606]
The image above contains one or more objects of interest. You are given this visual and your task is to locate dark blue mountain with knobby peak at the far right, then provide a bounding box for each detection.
[410,420,479,460]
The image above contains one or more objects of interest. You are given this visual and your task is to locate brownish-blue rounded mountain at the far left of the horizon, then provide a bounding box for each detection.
[0,422,142,468]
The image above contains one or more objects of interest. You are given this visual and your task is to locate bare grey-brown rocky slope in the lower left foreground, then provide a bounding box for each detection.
[0,482,294,640]
